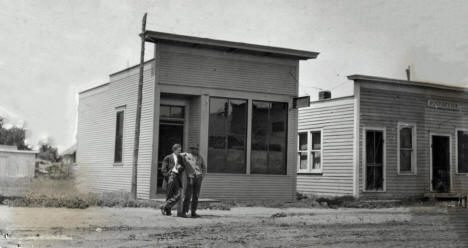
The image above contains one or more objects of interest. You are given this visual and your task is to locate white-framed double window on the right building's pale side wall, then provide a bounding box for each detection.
[298,131,322,173]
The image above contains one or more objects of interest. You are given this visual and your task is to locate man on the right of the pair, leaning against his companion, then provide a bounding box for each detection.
[183,146,206,218]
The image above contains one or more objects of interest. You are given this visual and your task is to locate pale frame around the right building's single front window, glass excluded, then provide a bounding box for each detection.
[397,122,418,176]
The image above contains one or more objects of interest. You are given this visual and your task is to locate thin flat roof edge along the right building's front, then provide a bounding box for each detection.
[347,74,468,92]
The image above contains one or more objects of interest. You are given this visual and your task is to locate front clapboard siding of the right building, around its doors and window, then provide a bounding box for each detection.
[359,81,468,196]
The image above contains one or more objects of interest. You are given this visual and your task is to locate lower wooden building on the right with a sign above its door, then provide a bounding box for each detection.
[297,75,468,198]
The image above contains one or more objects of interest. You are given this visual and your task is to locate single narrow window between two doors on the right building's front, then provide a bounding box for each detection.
[398,124,416,174]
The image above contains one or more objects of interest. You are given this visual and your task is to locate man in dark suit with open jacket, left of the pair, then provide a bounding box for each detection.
[161,144,186,217]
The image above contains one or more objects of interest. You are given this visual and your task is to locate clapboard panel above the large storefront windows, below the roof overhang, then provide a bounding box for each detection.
[158,44,298,96]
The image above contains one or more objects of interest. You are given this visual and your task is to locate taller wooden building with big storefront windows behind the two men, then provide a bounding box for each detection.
[77,31,318,200]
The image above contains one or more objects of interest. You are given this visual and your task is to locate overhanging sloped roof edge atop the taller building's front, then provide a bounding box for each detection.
[140,30,319,60]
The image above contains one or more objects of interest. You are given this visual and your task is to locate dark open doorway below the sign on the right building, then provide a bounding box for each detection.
[432,136,450,193]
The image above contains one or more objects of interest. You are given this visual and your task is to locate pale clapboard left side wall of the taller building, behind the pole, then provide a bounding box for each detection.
[77,64,154,198]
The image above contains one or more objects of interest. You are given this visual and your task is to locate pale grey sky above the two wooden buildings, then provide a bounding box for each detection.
[0,0,468,150]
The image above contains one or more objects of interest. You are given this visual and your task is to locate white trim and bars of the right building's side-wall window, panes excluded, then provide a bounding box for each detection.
[297,129,323,174]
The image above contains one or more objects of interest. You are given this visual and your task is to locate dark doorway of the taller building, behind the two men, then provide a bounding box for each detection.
[156,121,184,194]
